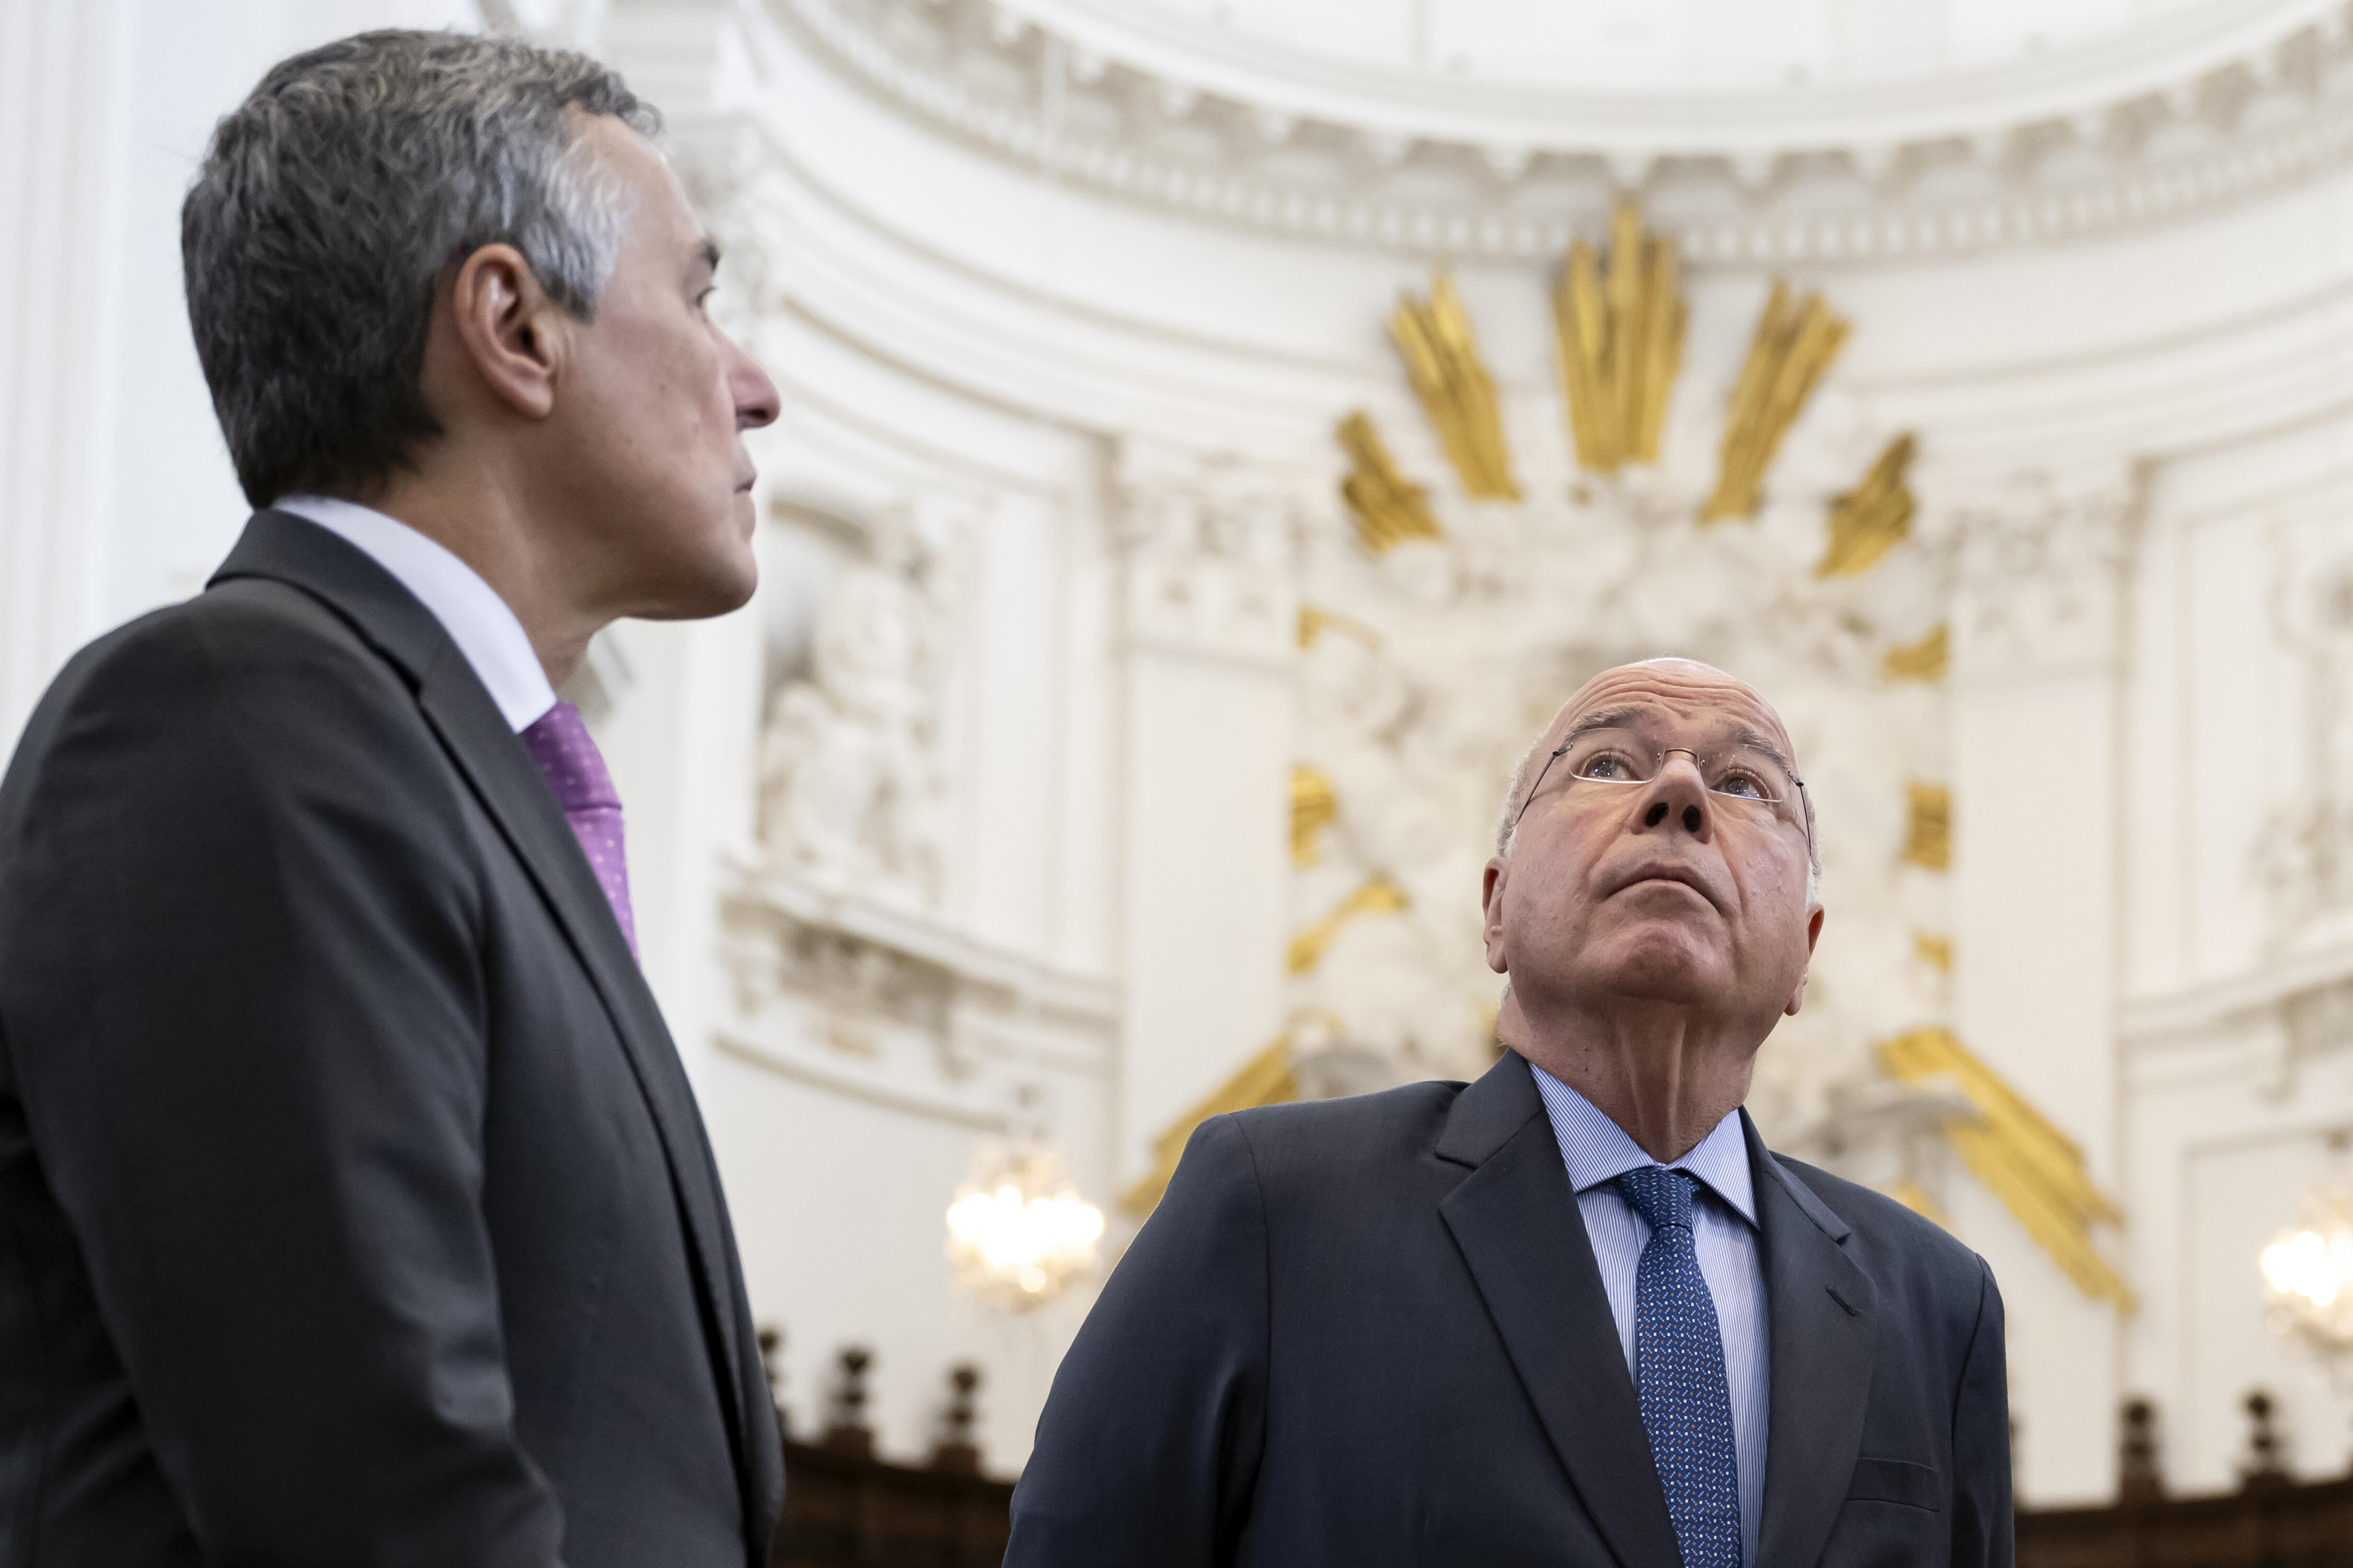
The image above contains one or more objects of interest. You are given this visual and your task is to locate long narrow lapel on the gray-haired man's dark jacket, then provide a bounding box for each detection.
[212,513,767,1507]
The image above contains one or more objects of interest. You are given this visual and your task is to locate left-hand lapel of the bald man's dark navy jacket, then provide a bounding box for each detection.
[1438,1053,1682,1568]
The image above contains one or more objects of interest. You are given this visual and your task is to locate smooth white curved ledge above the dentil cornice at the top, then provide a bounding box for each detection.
[988,0,2344,153]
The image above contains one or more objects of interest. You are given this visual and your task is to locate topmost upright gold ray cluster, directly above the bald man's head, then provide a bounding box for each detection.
[1553,202,1682,472]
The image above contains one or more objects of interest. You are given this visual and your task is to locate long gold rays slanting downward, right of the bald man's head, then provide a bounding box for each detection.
[1878,1030,2134,1312]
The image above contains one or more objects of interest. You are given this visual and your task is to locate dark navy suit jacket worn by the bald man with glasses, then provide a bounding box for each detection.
[1005,1053,2010,1568]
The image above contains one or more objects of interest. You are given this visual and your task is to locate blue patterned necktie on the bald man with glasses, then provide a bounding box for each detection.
[1619,1166,1741,1568]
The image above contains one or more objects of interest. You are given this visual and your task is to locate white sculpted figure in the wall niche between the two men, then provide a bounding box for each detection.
[760,505,972,910]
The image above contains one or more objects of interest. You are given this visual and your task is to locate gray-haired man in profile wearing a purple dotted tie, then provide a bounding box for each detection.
[0,33,783,1568]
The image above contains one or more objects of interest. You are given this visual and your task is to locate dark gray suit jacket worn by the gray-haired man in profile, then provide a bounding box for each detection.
[0,513,783,1568]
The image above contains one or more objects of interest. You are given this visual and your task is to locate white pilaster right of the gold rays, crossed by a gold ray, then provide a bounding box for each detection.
[1953,477,2132,1505]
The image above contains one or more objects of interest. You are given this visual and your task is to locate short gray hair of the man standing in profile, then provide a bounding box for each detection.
[179,30,661,505]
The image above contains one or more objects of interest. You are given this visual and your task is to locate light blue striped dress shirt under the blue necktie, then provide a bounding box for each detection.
[1529,1063,1767,1563]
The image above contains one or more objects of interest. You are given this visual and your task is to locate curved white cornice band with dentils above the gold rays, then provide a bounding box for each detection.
[765,0,2353,265]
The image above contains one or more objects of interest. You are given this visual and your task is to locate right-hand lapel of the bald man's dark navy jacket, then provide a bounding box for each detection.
[1741,1112,1878,1568]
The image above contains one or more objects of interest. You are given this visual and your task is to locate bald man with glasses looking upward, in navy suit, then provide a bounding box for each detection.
[1005,660,2012,1568]
